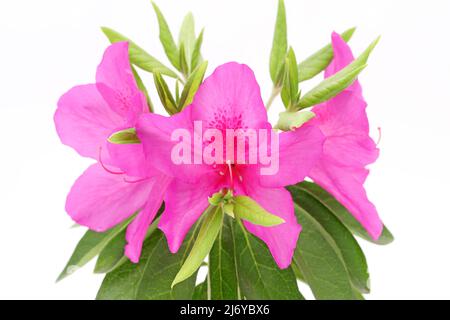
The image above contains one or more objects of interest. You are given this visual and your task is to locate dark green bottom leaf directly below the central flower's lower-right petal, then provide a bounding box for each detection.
[232,222,303,300]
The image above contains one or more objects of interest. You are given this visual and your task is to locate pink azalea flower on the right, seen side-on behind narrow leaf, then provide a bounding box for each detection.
[308,33,383,239]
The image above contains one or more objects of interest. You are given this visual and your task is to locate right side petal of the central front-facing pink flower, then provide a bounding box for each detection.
[260,126,325,187]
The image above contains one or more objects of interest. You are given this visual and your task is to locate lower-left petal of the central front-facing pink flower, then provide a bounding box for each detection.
[159,175,220,253]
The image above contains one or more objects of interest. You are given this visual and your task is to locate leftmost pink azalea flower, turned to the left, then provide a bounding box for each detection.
[54,42,170,262]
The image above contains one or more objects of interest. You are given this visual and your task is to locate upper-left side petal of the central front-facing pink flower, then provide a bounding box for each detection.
[136,107,214,183]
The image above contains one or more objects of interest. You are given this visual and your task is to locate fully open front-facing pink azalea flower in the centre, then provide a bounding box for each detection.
[136,63,324,268]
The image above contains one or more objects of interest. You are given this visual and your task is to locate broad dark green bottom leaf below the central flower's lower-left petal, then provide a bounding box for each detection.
[97,230,196,300]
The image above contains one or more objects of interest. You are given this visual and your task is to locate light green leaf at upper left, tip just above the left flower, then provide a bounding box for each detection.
[102,27,178,78]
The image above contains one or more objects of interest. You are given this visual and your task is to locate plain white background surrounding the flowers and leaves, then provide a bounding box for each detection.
[0,0,450,299]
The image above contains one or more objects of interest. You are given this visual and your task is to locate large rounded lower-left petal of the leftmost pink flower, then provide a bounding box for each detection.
[66,164,152,232]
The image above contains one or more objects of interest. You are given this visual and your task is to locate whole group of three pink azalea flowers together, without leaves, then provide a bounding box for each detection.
[54,34,383,268]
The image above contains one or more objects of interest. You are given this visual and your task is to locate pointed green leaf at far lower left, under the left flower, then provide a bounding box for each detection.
[56,218,131,281]
